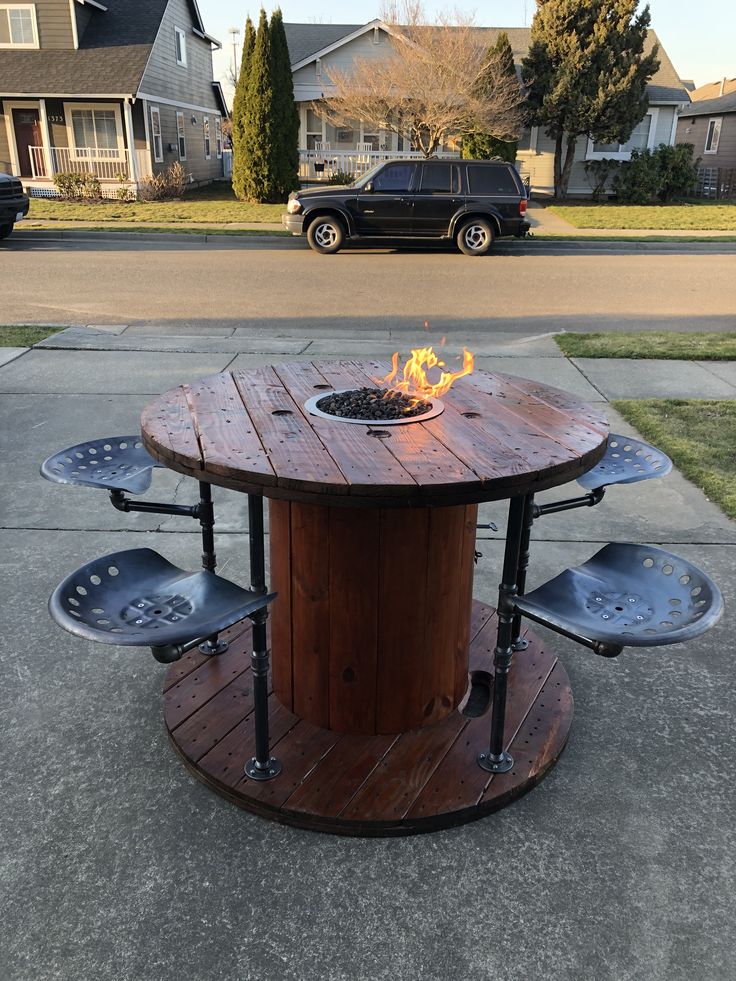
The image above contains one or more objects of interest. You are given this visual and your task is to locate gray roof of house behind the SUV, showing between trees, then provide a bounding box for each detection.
[284,20,690,102]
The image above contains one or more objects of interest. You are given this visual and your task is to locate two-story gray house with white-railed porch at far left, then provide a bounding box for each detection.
[0,0,227,196]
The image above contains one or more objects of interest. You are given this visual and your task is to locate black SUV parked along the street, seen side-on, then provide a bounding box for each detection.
[282,160,529,255]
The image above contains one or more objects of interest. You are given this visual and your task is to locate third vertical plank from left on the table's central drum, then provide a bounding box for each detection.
[328,508,381,733]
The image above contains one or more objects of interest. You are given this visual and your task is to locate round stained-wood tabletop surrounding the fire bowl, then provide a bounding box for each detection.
[141,361,608,507]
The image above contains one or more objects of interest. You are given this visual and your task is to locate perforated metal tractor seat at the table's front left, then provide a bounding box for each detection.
[49,548,276,664]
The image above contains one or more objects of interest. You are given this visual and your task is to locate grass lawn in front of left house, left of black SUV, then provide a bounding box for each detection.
[28,183,284,223]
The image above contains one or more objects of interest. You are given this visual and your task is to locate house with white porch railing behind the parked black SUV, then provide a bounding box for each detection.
[285,20,690,194]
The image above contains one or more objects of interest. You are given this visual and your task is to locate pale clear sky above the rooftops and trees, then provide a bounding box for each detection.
[199,0,736,98]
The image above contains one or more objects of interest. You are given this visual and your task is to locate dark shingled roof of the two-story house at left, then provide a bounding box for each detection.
[0,0,214,96]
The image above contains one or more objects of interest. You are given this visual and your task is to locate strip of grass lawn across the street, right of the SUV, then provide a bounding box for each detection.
[550,203,736,232]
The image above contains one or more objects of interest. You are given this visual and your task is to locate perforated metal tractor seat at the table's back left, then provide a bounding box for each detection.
[41,435,162,494]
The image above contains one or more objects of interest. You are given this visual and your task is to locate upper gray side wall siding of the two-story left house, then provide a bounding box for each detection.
[140,0,220,115]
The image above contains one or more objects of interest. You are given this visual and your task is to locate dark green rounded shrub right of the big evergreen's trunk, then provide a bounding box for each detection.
[613,143,698,204]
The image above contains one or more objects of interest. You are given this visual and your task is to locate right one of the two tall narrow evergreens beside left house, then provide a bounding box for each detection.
[270,8,299,202]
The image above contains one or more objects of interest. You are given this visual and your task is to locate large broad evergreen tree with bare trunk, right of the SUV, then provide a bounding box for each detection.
[522,0,659,198]
